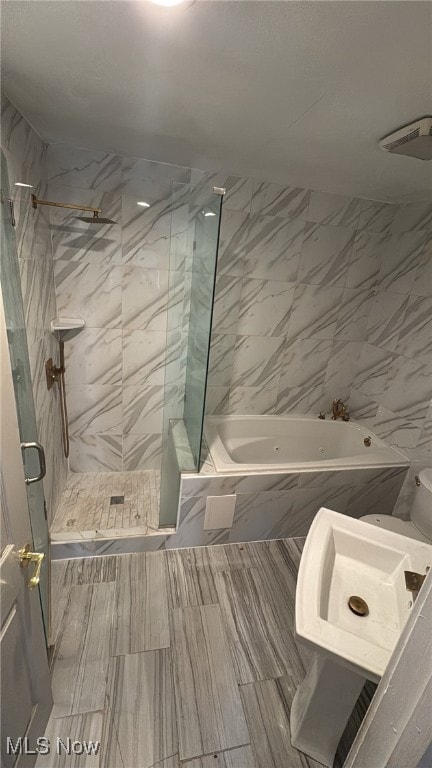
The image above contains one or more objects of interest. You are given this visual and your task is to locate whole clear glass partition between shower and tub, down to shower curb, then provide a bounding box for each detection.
[159,183,222,526]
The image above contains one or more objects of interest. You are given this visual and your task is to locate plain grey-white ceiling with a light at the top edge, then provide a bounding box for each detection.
[2,0,432,202]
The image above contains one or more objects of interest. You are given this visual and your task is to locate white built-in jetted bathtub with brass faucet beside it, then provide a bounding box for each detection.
[204,414,409,473]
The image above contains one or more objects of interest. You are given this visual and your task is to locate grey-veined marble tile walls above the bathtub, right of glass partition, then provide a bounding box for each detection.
[208,179,432,480]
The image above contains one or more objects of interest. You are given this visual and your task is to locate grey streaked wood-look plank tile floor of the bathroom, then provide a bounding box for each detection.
[41,539,372,768]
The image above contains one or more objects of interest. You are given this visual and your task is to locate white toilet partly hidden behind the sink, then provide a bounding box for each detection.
[360,467,432,544]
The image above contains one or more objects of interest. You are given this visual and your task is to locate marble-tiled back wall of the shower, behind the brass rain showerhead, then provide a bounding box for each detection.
[47,144,191,472]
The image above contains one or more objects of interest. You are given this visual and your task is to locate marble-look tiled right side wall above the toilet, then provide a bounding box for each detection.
[350,203,432,517]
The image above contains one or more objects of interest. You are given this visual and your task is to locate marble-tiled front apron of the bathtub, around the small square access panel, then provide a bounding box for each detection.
[172,467,407,548]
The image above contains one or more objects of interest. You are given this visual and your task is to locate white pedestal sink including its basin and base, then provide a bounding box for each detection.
[290,507,432,768]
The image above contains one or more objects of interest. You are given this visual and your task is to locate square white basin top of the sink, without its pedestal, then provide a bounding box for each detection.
[296,507,432,682]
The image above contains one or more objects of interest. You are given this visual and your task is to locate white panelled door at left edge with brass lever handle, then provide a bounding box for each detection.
[0,294,52,768]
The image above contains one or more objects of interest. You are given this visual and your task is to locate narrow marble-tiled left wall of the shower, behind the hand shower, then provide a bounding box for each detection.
[1,95,67,522]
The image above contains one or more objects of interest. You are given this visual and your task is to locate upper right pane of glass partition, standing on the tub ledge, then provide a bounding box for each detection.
[183,192,222,471]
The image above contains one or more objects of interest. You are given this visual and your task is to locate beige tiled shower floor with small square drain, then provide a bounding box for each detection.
[51,470,172,541]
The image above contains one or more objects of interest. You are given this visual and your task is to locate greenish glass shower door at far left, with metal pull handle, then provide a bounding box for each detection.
[0,152,49,640]
